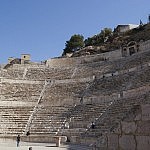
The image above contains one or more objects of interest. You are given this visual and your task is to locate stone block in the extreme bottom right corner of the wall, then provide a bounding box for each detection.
[136,136,150,150]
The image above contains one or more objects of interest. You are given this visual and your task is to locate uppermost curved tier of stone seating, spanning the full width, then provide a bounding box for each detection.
[0,48,150,80]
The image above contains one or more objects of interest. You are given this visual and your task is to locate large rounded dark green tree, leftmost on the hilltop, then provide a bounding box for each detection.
[62,34,84,55]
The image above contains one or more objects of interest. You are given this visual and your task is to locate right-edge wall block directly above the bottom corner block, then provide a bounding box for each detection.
[137,121,150,135]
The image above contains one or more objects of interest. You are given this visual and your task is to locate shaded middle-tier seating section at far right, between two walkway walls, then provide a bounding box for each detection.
[88,67,150,95]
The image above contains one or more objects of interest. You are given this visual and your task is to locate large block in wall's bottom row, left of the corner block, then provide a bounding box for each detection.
[119,135,136,150]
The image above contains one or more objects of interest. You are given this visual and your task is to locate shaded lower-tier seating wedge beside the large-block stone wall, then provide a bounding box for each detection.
[79,92,150,144]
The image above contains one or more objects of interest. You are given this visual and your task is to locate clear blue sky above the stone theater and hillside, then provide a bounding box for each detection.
[0,0,150,63]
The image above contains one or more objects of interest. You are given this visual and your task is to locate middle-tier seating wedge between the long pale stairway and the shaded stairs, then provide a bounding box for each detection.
[41,82,90,106]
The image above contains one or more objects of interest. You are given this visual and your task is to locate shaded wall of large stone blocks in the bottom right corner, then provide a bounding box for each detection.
[106,104,150,150]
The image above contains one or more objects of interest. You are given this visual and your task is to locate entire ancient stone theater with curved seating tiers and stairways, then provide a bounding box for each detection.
[0,24,150,150]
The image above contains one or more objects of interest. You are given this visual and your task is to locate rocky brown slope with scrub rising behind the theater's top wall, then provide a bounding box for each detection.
[72,24,150,57]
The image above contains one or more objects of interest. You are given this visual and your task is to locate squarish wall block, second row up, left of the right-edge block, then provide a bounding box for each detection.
[121,122,137,134]
